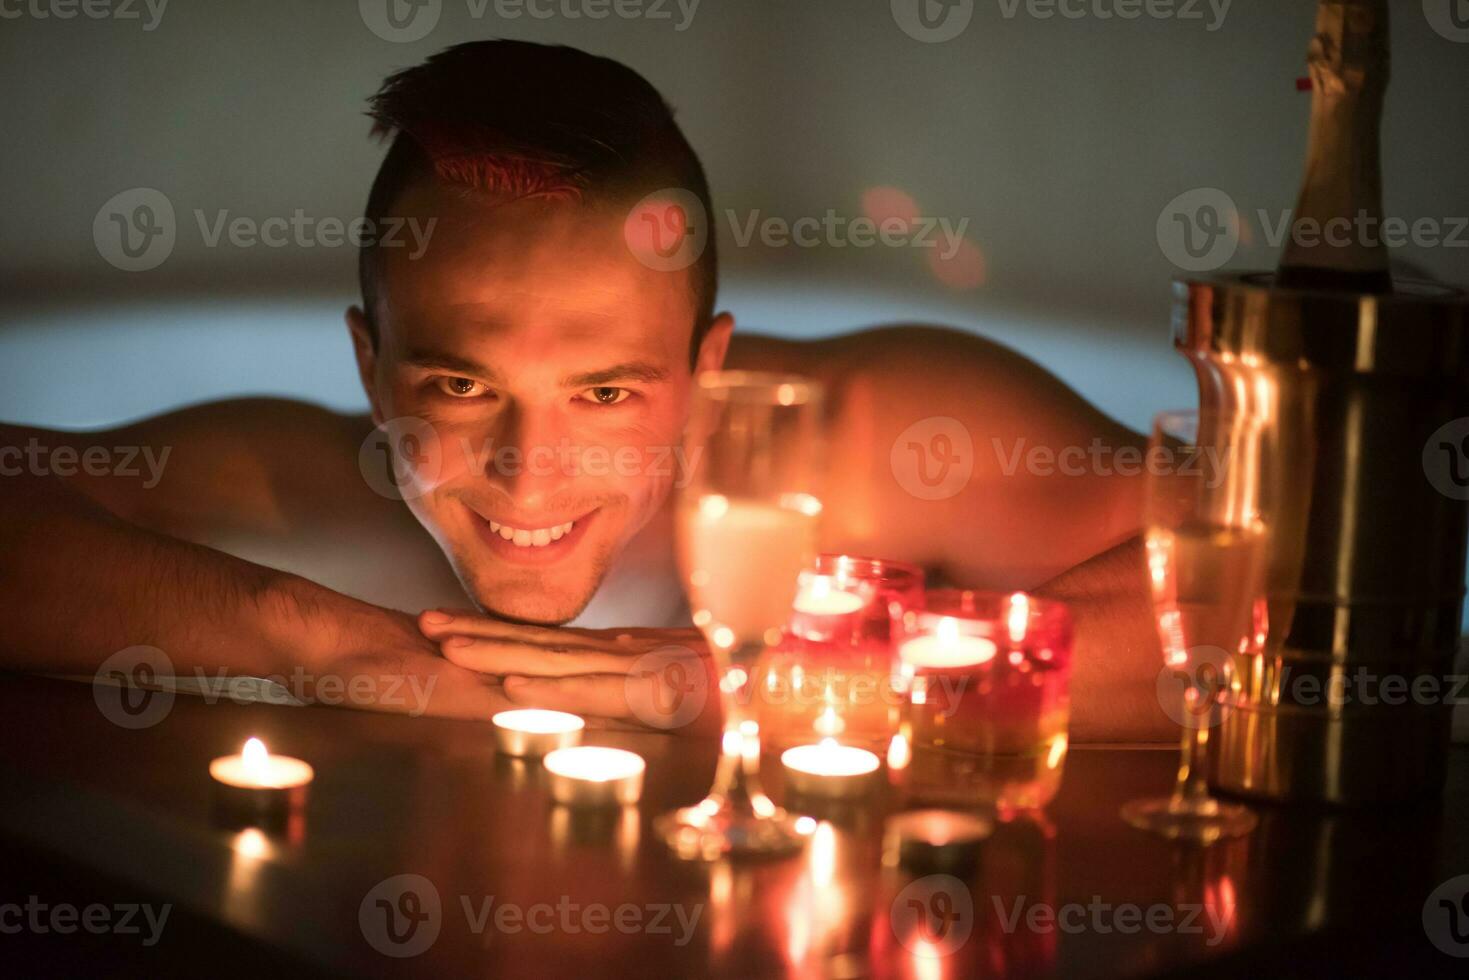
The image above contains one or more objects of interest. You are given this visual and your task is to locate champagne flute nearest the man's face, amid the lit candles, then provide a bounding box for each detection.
[657,372,821,860]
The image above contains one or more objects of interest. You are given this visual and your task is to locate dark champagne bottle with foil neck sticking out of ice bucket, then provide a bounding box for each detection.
[1277,0,1393,292]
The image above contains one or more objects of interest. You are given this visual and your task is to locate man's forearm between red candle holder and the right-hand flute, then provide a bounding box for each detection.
[1036,538,1178,742]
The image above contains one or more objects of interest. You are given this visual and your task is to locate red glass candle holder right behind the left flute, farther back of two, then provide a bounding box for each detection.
[754,554,923,751]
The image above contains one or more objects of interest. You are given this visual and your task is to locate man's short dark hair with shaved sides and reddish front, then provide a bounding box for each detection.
[357,40,717,363]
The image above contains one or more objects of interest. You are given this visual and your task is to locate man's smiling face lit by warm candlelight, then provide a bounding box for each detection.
[354,184,723,623]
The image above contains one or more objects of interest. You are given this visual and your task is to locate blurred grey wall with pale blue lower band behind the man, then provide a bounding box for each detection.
[0,0,1469,426]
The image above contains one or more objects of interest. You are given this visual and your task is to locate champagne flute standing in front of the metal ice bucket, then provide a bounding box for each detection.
[1122,411,1278,843]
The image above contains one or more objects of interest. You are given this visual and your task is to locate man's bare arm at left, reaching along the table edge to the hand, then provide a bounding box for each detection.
[0,408,504,717]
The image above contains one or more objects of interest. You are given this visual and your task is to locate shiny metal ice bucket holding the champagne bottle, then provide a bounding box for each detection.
[1174,273,1469,804]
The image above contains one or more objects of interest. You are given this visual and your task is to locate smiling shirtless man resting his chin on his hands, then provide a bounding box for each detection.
[0,41,1161,739]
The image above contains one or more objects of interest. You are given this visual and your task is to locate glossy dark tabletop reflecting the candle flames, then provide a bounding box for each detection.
[0,677,1469,980]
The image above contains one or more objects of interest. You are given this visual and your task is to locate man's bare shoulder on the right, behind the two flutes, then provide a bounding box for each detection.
[727,325,1141,586]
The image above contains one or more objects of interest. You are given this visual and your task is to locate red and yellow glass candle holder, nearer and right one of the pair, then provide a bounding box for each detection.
[889,589,1072,811]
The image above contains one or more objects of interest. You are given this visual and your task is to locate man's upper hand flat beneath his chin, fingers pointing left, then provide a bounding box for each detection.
[419,610,720,735]
